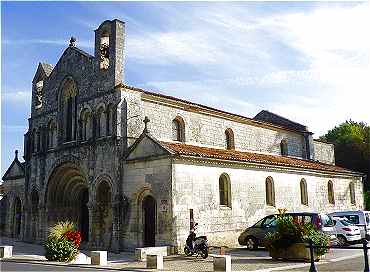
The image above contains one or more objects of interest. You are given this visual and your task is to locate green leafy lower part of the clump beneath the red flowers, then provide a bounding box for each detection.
[44,237,78,262]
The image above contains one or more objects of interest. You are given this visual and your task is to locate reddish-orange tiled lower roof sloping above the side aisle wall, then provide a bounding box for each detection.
[161,142,361,175]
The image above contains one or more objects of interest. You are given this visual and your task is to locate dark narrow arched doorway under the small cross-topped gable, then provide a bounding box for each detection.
[142,195,156,246]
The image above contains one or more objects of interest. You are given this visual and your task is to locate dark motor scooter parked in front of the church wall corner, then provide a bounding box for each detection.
[184,223,208,259]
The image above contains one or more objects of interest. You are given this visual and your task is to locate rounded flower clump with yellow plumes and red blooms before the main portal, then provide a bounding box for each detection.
[44,222,81,262]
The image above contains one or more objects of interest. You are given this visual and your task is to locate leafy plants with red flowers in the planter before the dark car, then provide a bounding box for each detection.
[265,216,330,256]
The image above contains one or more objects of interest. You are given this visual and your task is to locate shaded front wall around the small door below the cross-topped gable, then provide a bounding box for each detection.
[122,159,174,250]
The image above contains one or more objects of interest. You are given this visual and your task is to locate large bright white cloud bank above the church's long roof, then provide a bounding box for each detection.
[141,3,370,136]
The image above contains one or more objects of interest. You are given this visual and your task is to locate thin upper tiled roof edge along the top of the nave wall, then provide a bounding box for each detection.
[116,83,306,132]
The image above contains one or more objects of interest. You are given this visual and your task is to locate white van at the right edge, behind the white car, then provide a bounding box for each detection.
[329,210,370,240]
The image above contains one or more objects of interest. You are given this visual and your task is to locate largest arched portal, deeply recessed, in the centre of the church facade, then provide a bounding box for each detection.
[46,163,89,241]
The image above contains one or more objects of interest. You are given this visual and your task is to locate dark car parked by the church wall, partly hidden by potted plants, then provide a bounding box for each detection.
[238,212,337,250]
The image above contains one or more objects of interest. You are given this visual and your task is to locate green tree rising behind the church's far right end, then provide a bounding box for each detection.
[320,120,370,191]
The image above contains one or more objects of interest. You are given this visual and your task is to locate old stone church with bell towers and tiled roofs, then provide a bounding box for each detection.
[0,19,364,251]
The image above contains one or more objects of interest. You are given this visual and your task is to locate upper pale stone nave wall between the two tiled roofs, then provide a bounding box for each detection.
[121,90,305,158]
